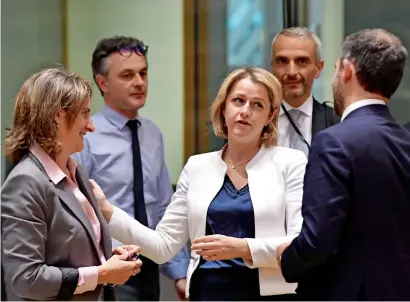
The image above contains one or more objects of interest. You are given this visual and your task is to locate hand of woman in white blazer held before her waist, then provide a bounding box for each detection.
[191,235,252,261]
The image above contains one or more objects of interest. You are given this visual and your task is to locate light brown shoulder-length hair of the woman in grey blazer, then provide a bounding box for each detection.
[5,68,91,164]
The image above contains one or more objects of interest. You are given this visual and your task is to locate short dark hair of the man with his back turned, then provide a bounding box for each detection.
[340,29,407,98]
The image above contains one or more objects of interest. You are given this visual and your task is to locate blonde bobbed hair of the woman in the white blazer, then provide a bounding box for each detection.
[211,68,282,147]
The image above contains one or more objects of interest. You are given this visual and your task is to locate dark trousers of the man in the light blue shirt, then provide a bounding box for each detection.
[115,256,160,301]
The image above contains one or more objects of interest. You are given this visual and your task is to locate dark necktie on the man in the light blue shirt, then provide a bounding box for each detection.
[127,119,148,226]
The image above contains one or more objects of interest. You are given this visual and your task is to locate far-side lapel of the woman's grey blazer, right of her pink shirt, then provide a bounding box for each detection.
[76,167,112,259]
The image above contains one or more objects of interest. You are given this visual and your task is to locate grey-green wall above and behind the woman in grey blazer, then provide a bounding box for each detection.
[0,0,62,183]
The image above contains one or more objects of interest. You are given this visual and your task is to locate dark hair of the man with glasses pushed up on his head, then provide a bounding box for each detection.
[91,36,147,95]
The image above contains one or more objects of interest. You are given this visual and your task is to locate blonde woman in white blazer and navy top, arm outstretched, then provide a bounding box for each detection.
[94,68,307,301]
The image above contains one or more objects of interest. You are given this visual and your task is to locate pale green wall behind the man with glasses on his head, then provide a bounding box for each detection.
[67,0,184,183]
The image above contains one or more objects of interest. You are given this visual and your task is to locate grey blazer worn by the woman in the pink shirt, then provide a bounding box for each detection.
[1,152,115,301]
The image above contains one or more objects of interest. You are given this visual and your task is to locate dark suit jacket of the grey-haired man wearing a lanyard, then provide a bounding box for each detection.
[312,98,340,139]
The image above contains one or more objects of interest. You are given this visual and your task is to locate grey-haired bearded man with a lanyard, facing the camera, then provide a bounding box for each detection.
[271,27,339,156]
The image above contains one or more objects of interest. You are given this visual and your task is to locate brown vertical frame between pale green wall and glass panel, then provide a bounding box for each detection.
[183,0,209,164]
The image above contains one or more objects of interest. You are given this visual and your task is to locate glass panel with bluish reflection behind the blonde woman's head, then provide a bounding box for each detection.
[204,0,283,152]
